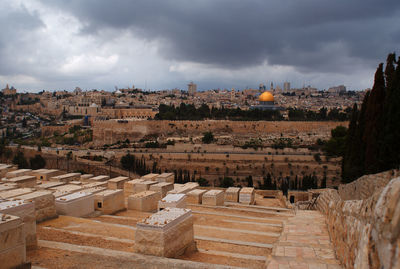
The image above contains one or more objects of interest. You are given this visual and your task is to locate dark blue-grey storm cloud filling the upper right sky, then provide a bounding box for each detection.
[39,0,400,72]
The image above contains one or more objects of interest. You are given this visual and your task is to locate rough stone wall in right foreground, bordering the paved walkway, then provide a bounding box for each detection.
[316,171,400,269]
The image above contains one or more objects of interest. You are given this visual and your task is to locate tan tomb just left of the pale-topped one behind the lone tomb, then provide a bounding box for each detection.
[128,191,161,212]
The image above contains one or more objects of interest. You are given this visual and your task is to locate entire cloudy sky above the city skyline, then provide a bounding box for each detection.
[0,0,400,91]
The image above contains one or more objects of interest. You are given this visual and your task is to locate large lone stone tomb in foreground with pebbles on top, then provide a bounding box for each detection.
[135,208,196,258]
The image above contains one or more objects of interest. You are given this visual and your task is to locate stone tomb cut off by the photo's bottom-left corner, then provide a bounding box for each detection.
[0,214,26,268]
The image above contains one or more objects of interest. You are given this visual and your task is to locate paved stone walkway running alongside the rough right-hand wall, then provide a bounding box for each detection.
[267,210,342,269]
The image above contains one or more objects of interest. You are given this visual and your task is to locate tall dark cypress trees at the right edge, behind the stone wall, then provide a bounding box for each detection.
[342,53,400,182]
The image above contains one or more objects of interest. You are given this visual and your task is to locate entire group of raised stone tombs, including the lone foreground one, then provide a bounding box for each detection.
[0,164,255,268]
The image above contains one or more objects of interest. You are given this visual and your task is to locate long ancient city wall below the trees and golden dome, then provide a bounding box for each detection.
[93,120,347,144]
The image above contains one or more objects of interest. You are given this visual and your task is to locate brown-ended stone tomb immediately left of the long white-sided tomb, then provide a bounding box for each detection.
[12,190,58,222]
